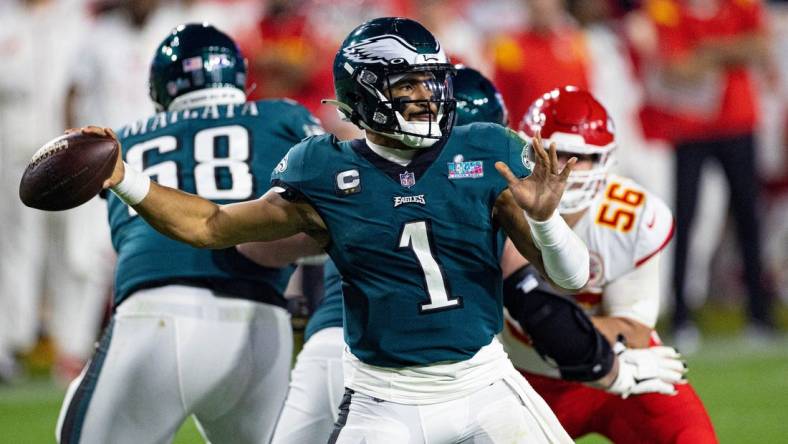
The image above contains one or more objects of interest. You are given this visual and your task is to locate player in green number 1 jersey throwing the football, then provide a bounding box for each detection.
[89,18,588,443]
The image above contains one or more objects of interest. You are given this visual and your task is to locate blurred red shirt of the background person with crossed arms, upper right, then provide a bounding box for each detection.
[641,0,764,142]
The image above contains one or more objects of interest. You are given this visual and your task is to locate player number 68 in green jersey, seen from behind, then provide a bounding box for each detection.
[56,24,320,443]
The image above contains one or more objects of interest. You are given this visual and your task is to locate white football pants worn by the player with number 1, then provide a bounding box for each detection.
[329,373,572,444]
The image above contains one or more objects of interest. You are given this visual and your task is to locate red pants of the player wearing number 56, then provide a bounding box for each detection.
[522,371,717,444]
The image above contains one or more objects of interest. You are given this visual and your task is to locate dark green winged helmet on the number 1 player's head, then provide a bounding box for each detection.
[327,17,455,148]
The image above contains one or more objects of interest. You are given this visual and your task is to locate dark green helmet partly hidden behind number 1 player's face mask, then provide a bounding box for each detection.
[454,65,509,126]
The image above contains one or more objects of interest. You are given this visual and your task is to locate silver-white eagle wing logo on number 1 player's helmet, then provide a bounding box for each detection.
[342,34,447,65]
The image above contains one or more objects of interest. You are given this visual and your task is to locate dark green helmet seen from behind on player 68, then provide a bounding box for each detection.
[149,23,246,111]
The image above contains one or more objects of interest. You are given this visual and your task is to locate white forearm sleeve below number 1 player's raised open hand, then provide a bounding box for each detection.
[525,211,589,290]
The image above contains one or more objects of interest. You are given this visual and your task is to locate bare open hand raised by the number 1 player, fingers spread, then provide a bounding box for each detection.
[495,132,577,220]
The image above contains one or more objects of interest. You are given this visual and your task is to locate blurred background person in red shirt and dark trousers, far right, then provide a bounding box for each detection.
[641,0,775,334]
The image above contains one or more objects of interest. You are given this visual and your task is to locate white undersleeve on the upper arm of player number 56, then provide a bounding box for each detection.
[602,253,662,328]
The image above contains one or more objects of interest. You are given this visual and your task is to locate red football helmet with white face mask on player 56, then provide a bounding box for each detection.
[520,86,615,214]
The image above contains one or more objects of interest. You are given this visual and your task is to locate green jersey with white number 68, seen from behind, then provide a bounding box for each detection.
[108,100,320,306]
